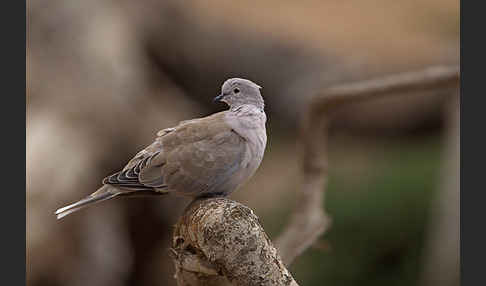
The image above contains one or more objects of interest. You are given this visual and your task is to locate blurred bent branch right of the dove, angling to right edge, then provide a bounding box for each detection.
[275,66,459,265]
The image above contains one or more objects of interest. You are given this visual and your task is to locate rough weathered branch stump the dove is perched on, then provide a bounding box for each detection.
[171,198,298,285]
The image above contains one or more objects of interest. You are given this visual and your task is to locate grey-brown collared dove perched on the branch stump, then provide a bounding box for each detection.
[55,78,267,219]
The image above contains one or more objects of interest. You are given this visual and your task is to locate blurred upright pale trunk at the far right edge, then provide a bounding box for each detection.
[420,91,460,286]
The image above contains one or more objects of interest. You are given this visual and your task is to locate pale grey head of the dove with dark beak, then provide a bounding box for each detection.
[214,78,264,110]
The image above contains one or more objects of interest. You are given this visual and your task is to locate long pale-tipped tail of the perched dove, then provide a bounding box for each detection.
[55,185,166,219]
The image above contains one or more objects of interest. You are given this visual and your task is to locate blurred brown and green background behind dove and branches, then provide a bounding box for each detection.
[26,0,460,286]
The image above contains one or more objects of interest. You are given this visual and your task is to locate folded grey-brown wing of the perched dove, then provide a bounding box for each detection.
[103,112,246,195]
